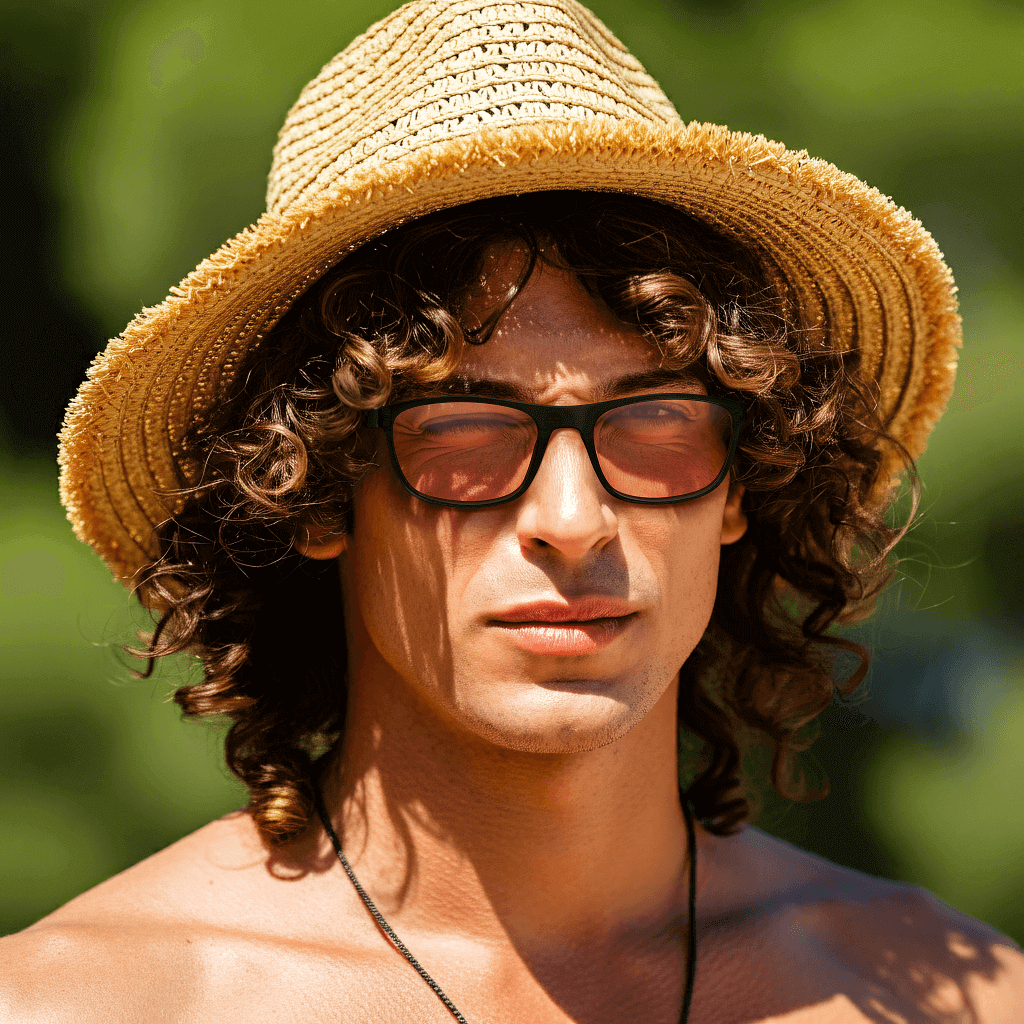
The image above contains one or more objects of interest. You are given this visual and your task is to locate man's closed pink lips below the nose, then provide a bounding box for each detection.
[488,597,637,657]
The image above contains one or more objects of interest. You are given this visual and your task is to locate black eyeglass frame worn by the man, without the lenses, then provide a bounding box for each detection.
[366,391,746,508]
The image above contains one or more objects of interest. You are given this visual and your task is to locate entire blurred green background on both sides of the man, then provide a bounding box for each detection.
[0,0,1024,941]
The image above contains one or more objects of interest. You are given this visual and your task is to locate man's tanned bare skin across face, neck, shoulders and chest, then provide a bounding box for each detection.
[0,260,1024,1024]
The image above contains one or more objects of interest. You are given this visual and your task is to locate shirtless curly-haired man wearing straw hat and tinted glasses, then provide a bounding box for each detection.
[0,0,1024,1024]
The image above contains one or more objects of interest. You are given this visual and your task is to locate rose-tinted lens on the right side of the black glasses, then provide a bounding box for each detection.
[594,398,732,498]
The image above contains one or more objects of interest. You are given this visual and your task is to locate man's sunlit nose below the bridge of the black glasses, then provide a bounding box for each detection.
[516,428,618,560]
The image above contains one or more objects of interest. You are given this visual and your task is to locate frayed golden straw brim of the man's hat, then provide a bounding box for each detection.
[59,117,961,585]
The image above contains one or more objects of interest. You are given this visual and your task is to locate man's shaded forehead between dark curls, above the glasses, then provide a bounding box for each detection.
[458,248,659,400]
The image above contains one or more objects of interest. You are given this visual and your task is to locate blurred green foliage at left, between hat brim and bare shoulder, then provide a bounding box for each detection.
[0,461,245,933]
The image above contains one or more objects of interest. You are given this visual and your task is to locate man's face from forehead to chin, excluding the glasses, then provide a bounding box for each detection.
[342,251,745,753]
